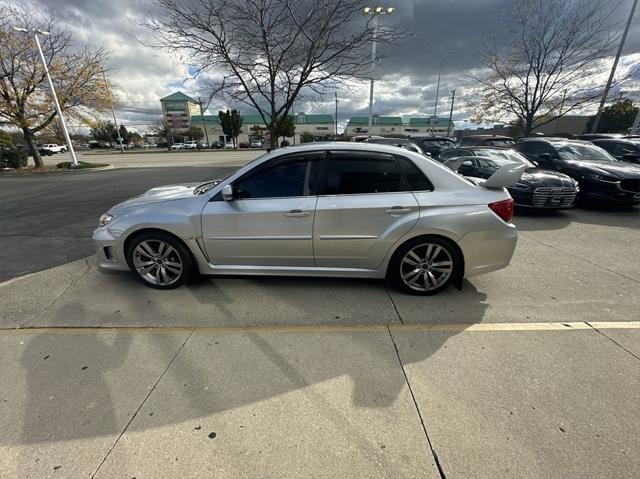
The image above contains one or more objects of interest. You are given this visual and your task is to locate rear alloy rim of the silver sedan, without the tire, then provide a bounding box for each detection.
[400,243,453,292]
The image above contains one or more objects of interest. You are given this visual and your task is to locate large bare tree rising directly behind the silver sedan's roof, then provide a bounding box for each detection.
[147,0,403,147]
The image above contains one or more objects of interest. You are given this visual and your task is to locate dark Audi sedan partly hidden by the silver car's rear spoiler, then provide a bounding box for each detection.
[440,146,578,209]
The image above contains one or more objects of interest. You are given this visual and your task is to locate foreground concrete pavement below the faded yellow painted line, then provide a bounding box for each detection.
[0,324,640,478]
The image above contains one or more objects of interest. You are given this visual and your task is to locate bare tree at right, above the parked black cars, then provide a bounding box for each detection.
[472,0,636,135]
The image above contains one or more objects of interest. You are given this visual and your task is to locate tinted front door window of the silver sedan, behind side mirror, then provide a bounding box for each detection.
[234,160,317,199]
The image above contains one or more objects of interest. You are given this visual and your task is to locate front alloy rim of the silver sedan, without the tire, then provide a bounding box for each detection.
[133,239,183,286]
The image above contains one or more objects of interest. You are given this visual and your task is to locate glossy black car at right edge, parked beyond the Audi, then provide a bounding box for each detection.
[515,138,640,205]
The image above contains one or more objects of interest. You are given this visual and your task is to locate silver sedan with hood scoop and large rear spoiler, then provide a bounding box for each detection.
[93,143,523,295]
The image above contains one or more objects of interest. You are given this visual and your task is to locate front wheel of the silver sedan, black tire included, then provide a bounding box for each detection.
[126,231,195,289]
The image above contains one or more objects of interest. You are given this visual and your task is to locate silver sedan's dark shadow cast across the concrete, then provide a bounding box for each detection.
[9,275,487,450]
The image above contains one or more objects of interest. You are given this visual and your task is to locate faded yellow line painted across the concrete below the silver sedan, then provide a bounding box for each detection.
[0,321,640,335]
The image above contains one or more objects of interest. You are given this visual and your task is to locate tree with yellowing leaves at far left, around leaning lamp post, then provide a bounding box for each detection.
[0,5,111,167]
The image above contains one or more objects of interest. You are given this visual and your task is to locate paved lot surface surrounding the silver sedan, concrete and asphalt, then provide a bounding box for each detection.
[0,152,640,479]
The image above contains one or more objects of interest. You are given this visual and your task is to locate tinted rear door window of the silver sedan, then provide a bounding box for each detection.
[326,154,405,195]
